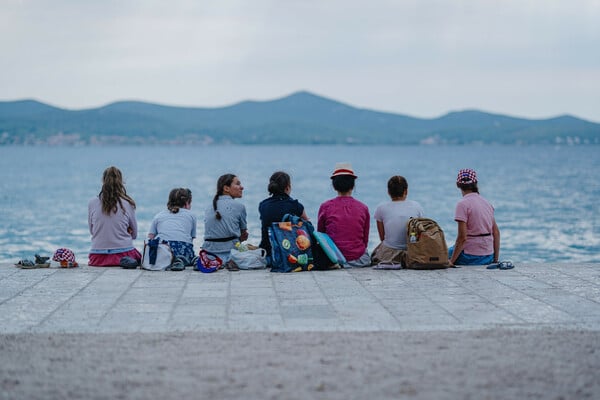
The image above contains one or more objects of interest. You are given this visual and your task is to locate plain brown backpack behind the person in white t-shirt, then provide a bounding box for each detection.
[405,218,450,269]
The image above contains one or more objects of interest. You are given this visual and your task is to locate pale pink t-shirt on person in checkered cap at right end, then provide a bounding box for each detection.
[454,193,494,256]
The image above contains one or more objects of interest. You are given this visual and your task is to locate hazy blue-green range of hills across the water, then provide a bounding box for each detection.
[0,92,600,145]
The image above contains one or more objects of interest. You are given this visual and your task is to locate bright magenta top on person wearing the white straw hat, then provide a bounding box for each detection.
[317,196,371,261]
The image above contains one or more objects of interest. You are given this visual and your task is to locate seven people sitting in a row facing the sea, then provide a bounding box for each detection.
[83,163,500,270]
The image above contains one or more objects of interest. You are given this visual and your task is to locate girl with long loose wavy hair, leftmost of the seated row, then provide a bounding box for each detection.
[88,166,142,267]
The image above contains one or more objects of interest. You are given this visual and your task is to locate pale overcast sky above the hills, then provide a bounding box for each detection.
[0,0,600,122]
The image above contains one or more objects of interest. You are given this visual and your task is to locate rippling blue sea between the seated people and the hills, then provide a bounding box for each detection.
[0,146,600,262]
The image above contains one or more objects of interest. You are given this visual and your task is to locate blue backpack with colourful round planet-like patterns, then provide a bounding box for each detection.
[269,214,314,272]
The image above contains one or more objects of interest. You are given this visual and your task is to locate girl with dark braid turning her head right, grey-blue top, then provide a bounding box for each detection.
[202,174,248,262]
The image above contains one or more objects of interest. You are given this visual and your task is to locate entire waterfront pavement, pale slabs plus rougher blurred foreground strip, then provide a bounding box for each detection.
[0,264,600,399]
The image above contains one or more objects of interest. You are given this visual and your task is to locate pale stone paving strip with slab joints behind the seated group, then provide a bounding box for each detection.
[0,264,600,334]
